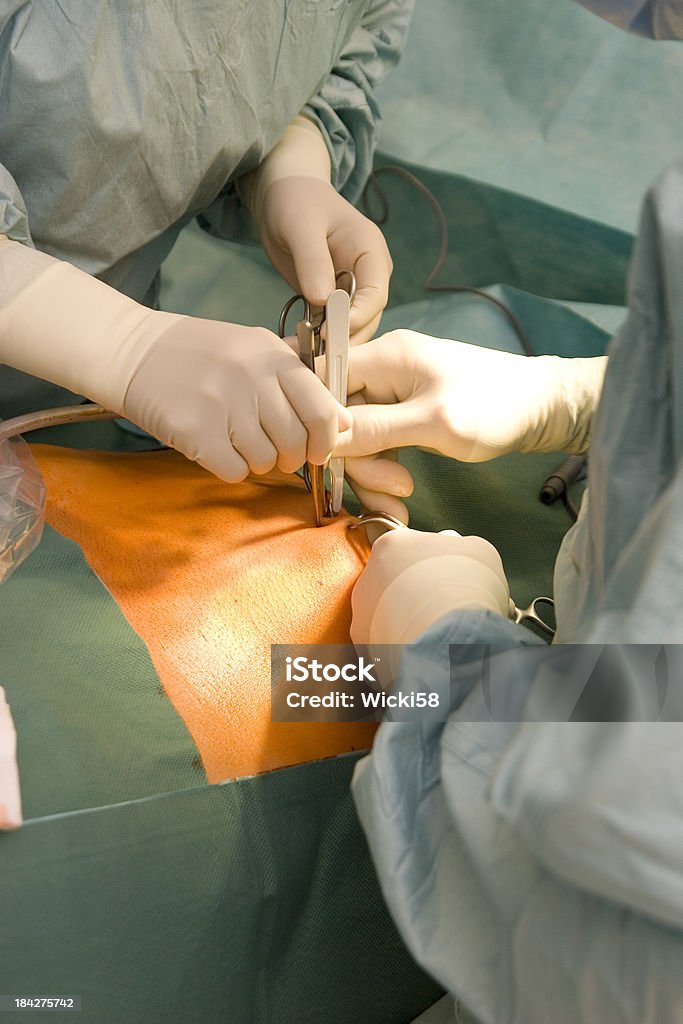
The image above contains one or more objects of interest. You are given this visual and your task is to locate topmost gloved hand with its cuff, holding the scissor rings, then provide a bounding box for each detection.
[239,117,392,345]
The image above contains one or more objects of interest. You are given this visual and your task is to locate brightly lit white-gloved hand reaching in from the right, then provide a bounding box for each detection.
[335,331,607,466]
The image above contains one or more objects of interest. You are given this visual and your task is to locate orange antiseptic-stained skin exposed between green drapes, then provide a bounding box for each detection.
[32,444,376,782]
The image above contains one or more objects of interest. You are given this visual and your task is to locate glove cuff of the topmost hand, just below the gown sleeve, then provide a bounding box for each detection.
[238,114,332,224]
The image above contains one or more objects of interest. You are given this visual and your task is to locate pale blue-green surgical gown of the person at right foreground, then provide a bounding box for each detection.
[353,28,683,1024]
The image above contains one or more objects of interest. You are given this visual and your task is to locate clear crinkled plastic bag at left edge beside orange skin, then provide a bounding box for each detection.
[0,437,45,584]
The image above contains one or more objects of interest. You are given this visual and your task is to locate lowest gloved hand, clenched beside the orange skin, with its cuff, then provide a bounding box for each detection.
[351,529,510,646]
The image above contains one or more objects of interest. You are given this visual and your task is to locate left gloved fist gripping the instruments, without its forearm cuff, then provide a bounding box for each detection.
[125,317,339,481]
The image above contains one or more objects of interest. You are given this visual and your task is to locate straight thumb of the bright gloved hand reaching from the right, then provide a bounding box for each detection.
[334,400,425,458]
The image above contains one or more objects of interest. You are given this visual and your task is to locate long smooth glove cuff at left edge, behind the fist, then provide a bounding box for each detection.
[0,242,182,413]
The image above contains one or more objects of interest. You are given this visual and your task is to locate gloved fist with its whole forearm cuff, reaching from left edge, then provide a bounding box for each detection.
[0,242,350,481]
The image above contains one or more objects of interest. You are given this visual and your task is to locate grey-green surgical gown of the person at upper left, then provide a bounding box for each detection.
[0,0,414,415]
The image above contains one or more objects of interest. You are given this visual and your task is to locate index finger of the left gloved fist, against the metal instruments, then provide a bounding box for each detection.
[279,364,348,466]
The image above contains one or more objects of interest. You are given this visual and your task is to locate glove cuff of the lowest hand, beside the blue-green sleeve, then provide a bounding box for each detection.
[368,555,510,645]
